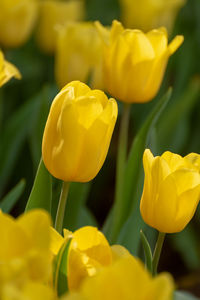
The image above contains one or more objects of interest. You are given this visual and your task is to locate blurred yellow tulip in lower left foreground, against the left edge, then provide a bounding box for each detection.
[0,210,51,284]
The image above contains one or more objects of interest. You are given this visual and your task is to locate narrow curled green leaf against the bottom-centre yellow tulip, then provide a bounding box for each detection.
[53,239,71,296]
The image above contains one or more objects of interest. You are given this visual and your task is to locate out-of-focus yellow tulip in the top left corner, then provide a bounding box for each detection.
[0,0,38,48]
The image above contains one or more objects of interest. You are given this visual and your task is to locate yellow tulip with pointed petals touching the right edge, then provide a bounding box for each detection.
[140,149,200,233]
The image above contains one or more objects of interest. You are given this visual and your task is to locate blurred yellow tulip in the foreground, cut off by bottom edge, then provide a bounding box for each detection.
[62,255,174,300]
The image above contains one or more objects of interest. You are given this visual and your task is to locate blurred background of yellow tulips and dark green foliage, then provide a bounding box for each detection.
[0,0,200,296]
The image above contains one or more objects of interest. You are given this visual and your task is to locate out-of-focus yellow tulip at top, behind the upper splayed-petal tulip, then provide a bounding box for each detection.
[120,0,186,31]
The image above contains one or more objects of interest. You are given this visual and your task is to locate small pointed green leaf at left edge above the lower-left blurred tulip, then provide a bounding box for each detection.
[0,179,25,213]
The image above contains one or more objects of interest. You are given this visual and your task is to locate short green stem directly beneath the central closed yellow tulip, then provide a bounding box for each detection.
[55,181,70,234]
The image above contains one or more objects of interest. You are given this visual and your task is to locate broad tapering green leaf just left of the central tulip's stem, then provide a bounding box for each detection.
[25,159,52,213]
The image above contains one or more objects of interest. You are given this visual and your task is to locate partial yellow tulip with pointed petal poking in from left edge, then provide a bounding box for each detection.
[0,50,21,87]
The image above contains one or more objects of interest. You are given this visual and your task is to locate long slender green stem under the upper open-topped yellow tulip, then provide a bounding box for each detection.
[111,103,131,243]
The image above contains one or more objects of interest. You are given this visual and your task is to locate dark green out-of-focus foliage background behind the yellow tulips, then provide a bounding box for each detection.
[0,0,200,296]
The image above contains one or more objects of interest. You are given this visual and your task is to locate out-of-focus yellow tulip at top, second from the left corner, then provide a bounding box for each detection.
[36,0,84,54]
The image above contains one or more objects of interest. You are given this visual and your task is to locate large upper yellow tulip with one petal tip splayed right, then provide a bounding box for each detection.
[96,21,183,103]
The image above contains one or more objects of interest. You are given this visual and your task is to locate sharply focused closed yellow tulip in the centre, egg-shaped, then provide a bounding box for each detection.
[42,81,117,182]
